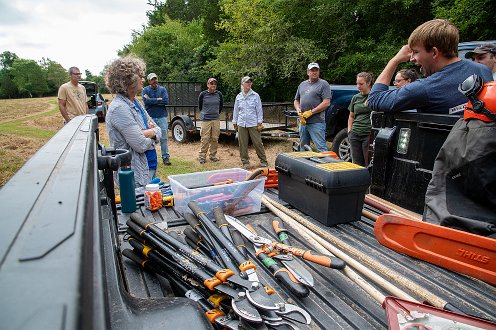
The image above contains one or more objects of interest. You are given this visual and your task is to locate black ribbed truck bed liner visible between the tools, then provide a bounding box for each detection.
[119,189,496,329]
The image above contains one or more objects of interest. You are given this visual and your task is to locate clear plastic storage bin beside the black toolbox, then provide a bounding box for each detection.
[169,168,266,216]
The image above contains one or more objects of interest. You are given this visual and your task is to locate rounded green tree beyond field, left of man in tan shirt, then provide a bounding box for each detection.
[11,59,48,97]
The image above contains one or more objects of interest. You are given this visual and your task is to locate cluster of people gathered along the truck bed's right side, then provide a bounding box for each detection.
[342,19,496,166]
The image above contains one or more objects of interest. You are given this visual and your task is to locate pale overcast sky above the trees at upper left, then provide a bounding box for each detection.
[0,0,152,75]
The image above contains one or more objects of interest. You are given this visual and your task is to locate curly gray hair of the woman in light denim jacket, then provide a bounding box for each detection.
[104,55,146,94]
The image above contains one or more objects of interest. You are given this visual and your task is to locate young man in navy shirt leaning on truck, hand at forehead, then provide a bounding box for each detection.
[368,19,493,115]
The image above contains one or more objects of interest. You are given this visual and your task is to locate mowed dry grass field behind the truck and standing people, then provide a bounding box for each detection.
[0,95,292,187]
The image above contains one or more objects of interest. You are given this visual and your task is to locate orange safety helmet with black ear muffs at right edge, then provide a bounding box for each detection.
[458,74,496,123]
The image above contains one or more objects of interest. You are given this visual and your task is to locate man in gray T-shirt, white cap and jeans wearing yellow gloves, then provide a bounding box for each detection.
[294,63,331,152]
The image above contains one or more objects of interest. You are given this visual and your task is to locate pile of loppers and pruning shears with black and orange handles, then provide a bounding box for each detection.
[123,202,320,329]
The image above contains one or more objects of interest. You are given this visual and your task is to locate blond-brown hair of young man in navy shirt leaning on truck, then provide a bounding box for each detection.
[408,19,460,58]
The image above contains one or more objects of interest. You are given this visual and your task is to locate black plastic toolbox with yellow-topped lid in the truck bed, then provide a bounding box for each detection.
[276,152,370,226]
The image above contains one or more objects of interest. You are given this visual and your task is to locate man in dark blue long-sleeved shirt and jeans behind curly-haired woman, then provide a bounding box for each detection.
[141,72,171,165]
